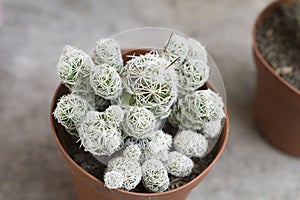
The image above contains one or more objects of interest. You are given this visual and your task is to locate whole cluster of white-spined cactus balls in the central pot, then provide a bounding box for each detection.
[53,33,225,192]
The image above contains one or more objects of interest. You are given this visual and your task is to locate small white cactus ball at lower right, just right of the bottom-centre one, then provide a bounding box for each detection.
[164,151,194,177]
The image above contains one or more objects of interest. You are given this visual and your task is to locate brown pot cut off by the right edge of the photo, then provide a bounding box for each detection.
[252,0,300,156]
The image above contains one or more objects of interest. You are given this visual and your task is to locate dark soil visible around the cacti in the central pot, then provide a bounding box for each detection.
[61,119,218,193]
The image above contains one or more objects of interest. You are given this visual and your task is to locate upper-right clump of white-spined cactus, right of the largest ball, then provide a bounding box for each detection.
[164,34,209,96]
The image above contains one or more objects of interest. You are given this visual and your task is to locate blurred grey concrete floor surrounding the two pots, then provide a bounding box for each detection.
[0,0,300,200]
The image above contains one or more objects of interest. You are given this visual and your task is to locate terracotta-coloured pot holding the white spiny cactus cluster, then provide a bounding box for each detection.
[50,50,229,200]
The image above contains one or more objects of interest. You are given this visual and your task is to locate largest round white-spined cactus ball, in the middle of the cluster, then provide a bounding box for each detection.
[121,52,177,118]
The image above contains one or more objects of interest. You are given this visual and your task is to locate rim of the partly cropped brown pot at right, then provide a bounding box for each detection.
[252,0,300,96]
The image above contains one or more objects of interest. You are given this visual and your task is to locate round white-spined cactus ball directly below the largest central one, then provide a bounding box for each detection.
[122,106,155,138]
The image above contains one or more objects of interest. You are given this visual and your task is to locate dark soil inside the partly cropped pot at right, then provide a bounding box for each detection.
[256,4,300,90]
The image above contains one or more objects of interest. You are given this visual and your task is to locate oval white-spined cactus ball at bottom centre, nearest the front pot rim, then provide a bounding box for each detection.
[142,159,169,192]
